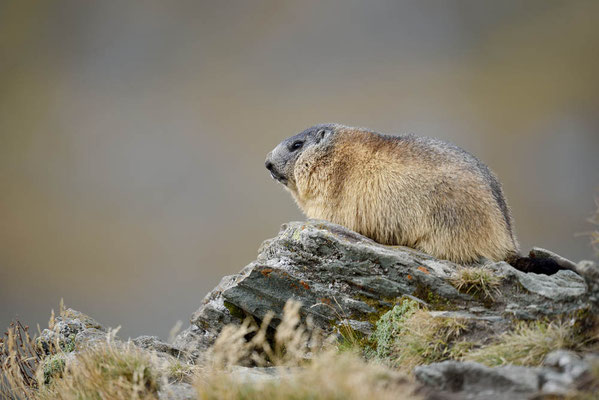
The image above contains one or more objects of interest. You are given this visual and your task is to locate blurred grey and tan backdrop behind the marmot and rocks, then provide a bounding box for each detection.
[0,0,599,338]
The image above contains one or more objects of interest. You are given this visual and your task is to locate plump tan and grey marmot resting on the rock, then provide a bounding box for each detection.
[266,124,560,273]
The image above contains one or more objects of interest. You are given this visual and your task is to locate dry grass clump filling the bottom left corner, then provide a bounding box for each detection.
[0,307,158,400]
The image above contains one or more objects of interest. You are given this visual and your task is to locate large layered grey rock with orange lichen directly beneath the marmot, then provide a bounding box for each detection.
[175,220,599,357]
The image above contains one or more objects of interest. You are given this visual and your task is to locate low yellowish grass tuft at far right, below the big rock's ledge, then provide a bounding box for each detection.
[464,321,588,366]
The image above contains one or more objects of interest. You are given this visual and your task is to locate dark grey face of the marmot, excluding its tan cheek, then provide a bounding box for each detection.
[265,124,336,190]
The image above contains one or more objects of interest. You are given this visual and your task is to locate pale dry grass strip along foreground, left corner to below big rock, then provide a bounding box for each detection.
[2,302,418,400]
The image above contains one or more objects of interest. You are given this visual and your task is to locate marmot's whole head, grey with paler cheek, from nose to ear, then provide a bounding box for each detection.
[265,124,339,192]
